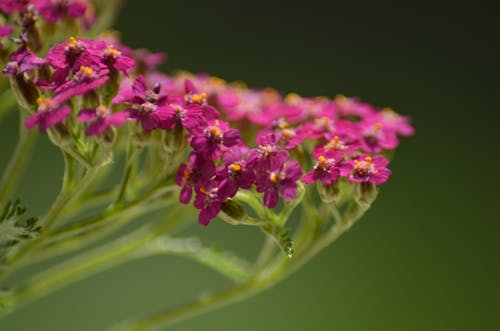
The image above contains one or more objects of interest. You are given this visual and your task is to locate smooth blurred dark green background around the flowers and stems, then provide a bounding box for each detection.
[0,0,500,331]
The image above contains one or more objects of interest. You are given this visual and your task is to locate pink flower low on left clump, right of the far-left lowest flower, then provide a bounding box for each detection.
[77,106,128,136]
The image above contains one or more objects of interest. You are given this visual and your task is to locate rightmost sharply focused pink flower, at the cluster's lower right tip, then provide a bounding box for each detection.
[342,154,391,185]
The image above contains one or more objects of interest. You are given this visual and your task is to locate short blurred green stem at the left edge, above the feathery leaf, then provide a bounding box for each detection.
[0,125,37,206]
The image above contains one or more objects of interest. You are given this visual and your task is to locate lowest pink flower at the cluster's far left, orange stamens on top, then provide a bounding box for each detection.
[24,98,71,132]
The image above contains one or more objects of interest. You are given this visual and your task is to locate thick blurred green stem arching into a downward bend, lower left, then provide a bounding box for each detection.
[5,209,249,313]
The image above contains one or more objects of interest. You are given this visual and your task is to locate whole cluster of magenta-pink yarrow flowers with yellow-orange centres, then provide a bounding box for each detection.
[0,0,413,225]
